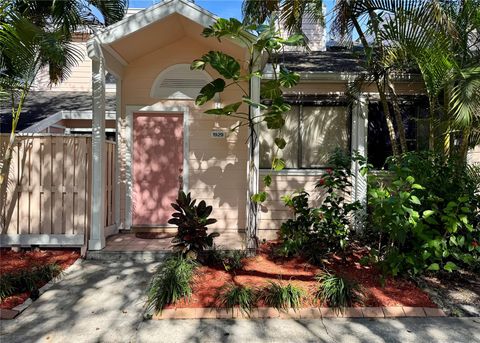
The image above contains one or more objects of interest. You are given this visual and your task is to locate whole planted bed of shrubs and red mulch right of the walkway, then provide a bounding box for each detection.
[147,151,480,318]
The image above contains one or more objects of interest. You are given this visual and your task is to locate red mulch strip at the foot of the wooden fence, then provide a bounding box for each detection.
[0,249,80,309]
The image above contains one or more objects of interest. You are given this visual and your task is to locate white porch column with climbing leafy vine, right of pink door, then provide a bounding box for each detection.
[246,77,261,253]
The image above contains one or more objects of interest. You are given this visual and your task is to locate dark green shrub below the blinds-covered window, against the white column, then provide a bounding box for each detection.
[278,150,362,262]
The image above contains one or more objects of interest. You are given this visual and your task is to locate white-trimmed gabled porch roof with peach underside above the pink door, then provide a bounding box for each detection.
[87,0,245,78]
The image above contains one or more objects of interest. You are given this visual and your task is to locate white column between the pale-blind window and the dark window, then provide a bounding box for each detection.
[352,97,368,230]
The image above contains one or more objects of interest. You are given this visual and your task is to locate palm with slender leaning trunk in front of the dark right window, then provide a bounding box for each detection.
[243,0,407,155]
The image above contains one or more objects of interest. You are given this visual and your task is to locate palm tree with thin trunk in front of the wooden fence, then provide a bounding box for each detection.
[0,0,127,220]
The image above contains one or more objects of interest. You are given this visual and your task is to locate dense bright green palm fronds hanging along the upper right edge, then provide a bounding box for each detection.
[382,0,480,160]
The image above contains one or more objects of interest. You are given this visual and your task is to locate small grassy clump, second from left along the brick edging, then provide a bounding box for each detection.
[217,284,257,315]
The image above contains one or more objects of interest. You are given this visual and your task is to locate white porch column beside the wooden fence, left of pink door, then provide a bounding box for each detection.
[88,56,105,250]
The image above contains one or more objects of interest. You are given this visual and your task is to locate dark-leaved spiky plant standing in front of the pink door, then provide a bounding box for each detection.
[168,191,220,259]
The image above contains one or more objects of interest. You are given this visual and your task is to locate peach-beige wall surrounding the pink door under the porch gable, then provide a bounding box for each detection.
[119,34,248,231]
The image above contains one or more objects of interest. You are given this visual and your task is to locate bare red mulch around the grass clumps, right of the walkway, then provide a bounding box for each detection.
[167,242,437,308]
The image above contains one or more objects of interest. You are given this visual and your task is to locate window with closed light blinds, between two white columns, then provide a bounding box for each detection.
[260,105,350,169]
